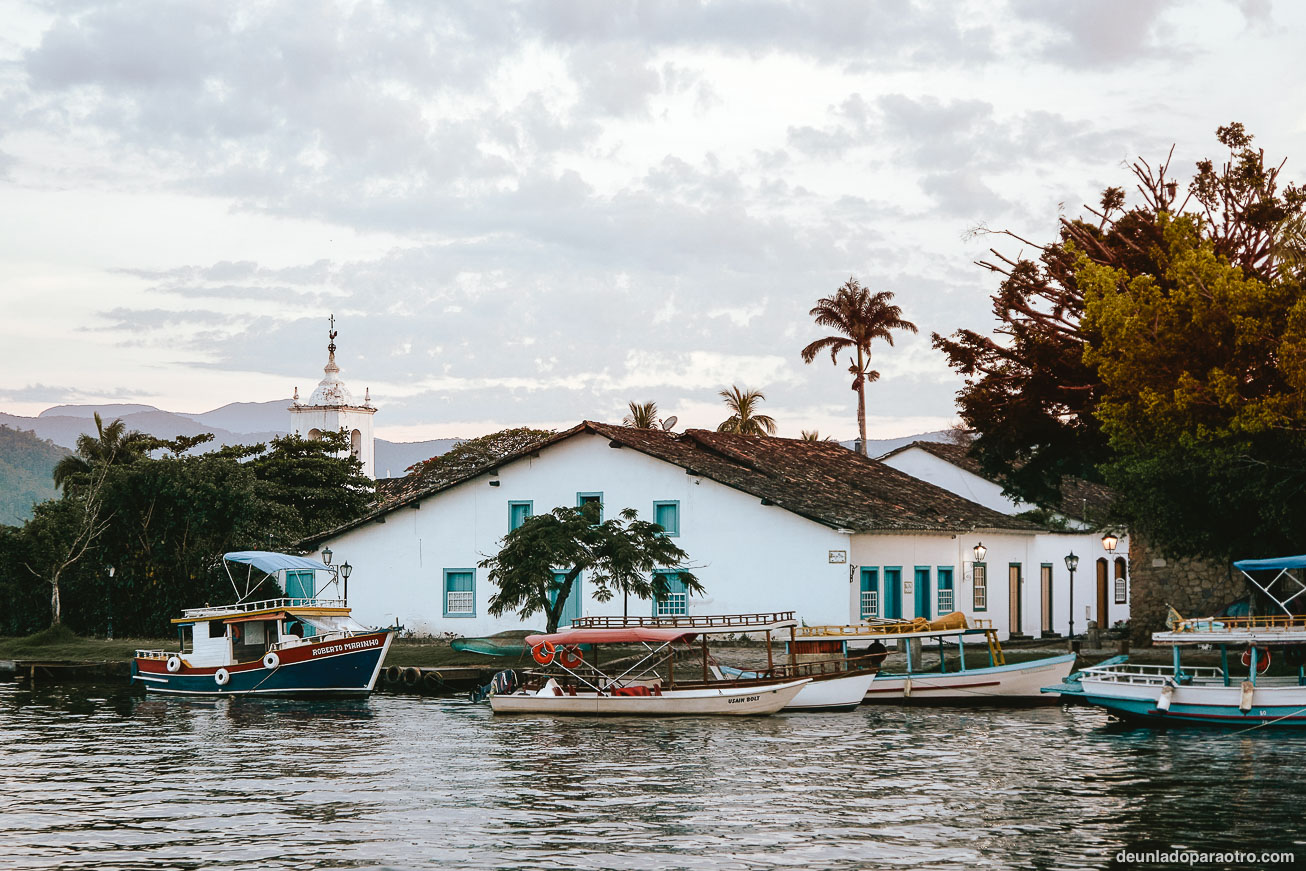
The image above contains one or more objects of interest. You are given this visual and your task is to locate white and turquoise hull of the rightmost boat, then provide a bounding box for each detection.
[1076,678,1306,729]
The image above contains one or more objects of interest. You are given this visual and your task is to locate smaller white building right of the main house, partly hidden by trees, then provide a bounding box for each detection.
[880,441,1130,633]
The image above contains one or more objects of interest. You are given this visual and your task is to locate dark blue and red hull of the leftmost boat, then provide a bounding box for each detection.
[132,632,394,697]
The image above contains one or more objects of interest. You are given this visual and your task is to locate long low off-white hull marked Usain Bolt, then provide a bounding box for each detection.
[490,679,810,717]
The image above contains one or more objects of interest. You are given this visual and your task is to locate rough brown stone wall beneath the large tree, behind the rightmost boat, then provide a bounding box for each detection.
[1130,535,1247,646]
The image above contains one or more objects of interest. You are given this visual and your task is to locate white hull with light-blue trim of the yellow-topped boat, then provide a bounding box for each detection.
[866,653,1075,704]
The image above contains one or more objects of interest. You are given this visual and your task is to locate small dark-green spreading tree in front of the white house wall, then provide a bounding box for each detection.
[479,503,703,632]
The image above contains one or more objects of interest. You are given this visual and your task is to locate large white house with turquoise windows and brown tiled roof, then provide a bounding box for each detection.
[304,422,1117,637]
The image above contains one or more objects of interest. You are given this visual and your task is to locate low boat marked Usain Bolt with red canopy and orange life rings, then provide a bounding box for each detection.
[490,627,810,717]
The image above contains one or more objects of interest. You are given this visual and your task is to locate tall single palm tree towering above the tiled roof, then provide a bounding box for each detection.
[802,278,917,457]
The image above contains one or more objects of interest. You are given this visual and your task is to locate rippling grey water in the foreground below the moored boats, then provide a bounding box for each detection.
[0,683,1306,871]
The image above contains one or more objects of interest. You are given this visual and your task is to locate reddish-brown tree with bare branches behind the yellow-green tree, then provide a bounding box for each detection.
[932,124,1306,507]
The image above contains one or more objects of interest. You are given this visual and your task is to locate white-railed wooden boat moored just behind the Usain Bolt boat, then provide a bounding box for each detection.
[572,611,879,710]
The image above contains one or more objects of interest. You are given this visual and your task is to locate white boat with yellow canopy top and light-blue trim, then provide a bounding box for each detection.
[791,611,1075,704]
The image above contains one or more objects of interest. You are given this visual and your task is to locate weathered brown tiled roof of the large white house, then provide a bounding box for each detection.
[300,420,1041,546]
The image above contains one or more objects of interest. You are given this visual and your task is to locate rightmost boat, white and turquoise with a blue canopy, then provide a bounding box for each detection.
[1045,556,1306,727]
